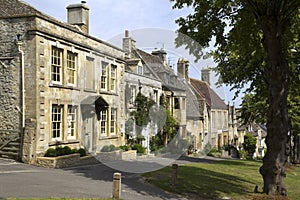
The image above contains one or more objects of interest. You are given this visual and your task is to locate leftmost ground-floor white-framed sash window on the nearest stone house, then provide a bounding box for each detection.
[51,105,62,140]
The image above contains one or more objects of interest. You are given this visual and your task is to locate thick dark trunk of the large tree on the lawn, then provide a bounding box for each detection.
[260,18,290,195]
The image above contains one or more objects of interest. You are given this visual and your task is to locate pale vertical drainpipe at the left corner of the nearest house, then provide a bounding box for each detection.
[17,41,25,131]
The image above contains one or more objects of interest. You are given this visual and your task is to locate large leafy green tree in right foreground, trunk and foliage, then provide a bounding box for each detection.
[171,0,300,195]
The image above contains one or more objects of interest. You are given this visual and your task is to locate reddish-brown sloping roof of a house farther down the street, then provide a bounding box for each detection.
[190,78,227,110]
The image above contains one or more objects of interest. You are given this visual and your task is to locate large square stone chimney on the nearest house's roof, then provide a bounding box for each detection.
[67,1,90,34]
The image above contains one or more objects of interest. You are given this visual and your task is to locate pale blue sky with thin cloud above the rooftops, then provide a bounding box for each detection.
[23,0,241,105]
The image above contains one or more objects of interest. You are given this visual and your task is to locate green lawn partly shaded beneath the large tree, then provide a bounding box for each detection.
[144,160,300,200]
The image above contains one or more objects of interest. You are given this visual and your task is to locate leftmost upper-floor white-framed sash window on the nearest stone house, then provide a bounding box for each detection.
[51,47,62,83]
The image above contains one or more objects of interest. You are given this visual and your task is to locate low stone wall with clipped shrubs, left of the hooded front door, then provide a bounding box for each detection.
[36,153,80,168]
